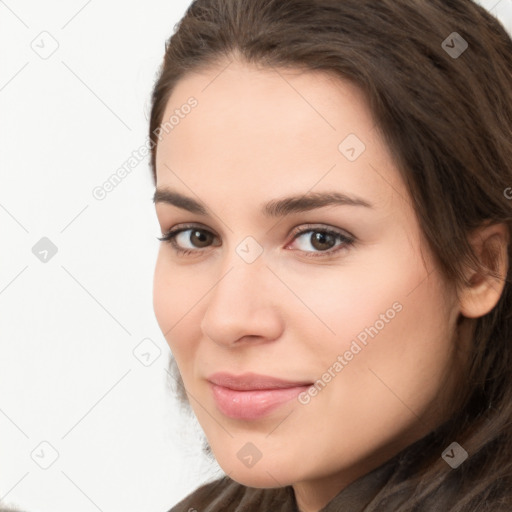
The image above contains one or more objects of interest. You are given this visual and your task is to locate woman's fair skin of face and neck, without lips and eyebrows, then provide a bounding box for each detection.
[154,56,506,512]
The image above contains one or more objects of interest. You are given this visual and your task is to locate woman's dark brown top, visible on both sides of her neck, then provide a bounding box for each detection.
[169,458,404,512]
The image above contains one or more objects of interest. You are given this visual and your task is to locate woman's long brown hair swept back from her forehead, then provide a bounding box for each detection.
[149,0,512,512]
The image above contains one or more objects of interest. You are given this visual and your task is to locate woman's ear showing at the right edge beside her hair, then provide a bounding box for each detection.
[459,223,510,318]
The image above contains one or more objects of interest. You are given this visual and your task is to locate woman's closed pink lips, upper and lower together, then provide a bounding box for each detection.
[207,373,313,420]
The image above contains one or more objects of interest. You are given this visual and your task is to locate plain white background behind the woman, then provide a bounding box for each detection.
[0,0,512,512]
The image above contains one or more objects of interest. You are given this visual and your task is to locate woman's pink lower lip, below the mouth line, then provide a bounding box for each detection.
[210,382,311,420]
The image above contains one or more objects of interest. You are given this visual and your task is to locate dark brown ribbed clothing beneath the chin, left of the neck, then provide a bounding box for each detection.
[164,476,297,512]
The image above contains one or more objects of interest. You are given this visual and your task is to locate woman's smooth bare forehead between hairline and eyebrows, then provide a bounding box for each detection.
[156,61,405,216]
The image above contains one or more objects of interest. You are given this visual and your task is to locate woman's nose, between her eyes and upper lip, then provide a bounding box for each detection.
[201,261,284,347]
